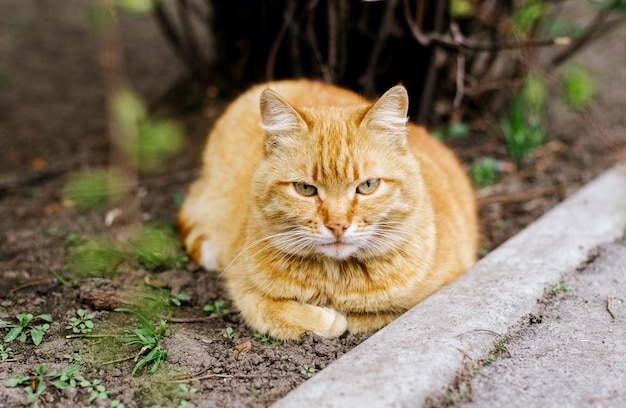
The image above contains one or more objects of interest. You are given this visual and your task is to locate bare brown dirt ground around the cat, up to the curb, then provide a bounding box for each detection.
[0,0,626,407]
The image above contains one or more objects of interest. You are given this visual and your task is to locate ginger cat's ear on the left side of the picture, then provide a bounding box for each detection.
[260,89,306,150]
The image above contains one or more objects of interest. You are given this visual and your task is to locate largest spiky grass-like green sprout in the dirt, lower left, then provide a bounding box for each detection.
[115,308,167,375]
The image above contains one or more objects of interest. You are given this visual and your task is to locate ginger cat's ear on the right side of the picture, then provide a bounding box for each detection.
[361,85,409,144]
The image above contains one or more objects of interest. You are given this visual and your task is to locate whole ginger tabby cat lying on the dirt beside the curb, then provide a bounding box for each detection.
[178,80,478,339]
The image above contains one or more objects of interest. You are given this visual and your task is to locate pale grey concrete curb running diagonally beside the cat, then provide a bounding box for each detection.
[273,166,626,408]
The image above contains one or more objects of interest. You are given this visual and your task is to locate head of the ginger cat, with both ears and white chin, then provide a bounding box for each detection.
[253,86,422,261]
